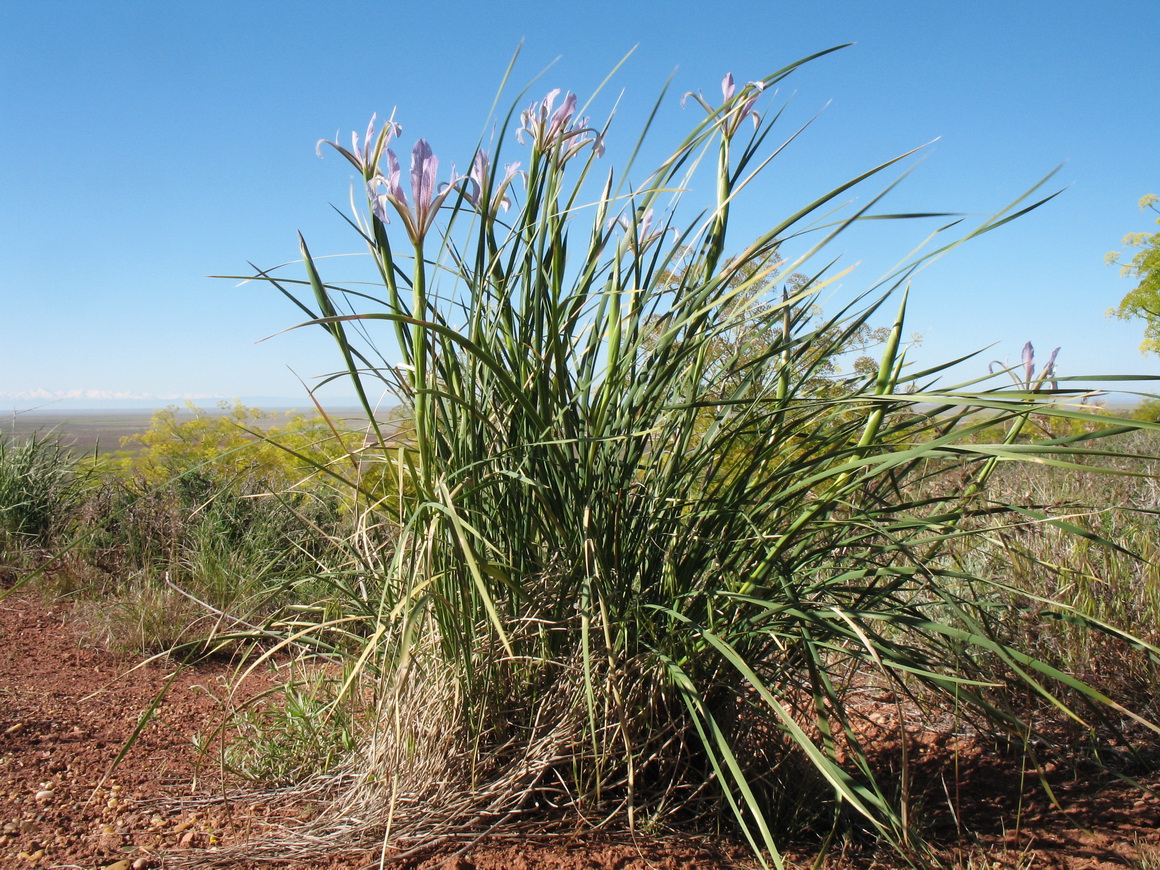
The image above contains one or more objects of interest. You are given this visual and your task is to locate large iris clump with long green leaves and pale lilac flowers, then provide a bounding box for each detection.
[133,52,1157,864]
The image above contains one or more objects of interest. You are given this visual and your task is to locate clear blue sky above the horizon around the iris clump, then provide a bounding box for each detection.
[0,0,1160,407]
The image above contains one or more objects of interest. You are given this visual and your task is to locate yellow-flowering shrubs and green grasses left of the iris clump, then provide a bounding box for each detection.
[0,406,383,653]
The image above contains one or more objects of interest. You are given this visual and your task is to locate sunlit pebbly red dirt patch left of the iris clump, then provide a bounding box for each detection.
[0,597,283,870]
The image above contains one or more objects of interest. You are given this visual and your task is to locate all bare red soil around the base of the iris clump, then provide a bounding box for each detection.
[0,594,1160,870]
